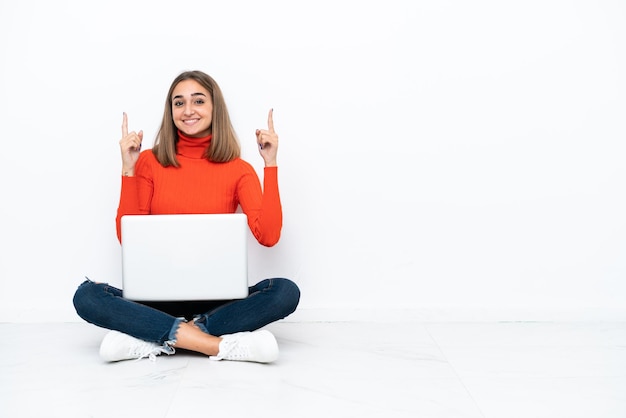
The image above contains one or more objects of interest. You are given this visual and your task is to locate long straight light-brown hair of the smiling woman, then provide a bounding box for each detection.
[152,71,241,167]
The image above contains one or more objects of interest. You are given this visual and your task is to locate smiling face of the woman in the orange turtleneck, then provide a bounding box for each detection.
[171,80,213,138]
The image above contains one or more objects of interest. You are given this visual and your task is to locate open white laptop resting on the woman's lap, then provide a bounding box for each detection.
[121,213,248,301]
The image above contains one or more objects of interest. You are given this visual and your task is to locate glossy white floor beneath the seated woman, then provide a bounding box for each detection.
[0,322,626,418]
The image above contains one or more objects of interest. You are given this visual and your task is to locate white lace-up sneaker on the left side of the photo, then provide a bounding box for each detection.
[100,331,175,361]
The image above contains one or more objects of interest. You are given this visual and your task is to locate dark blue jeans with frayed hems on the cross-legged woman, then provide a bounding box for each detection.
[74,278,300,345]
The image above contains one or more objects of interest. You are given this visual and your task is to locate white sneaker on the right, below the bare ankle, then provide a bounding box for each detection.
[209,330,278,363]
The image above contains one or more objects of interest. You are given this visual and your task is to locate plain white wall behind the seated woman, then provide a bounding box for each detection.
[0,0,626,321]
